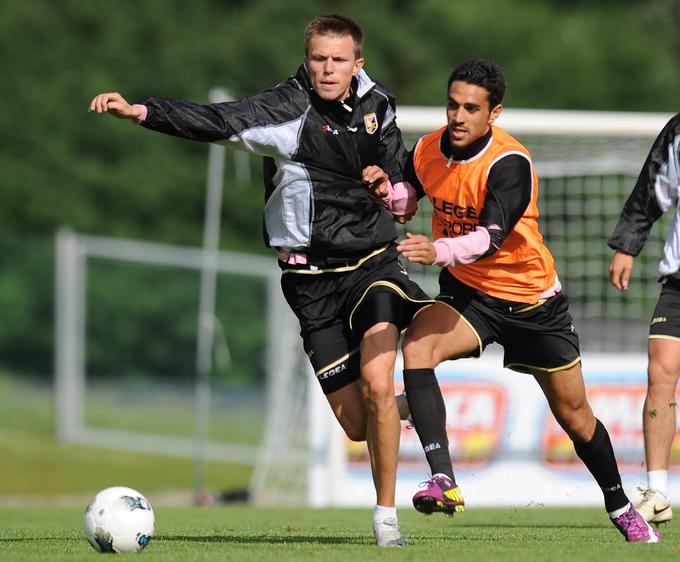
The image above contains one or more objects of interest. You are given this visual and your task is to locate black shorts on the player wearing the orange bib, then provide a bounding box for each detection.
[437,269,581,373]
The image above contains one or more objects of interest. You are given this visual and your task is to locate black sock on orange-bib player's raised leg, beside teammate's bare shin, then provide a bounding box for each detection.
[404,369,455,476]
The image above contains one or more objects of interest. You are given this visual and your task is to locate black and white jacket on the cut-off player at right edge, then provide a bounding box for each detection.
[608,113,680,279]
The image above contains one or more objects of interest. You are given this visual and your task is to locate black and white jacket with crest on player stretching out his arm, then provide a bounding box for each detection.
[137,65,408,263]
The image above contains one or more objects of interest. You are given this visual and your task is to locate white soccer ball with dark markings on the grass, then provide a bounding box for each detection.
[84,486,155,552]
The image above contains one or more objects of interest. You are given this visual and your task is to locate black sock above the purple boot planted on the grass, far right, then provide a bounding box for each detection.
[574,420,629,512]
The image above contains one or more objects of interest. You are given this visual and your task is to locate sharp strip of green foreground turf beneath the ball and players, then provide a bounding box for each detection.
[0,506,680,562]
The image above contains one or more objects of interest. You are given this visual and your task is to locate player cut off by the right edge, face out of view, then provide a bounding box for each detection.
[608,113,680,526]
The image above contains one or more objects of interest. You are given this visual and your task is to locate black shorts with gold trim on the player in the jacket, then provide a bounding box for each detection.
[280,244,434,394]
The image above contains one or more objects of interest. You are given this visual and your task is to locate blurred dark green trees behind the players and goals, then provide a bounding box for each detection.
[0,0,680,381]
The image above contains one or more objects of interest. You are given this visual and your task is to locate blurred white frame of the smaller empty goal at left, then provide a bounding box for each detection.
[55,229,297,464]
